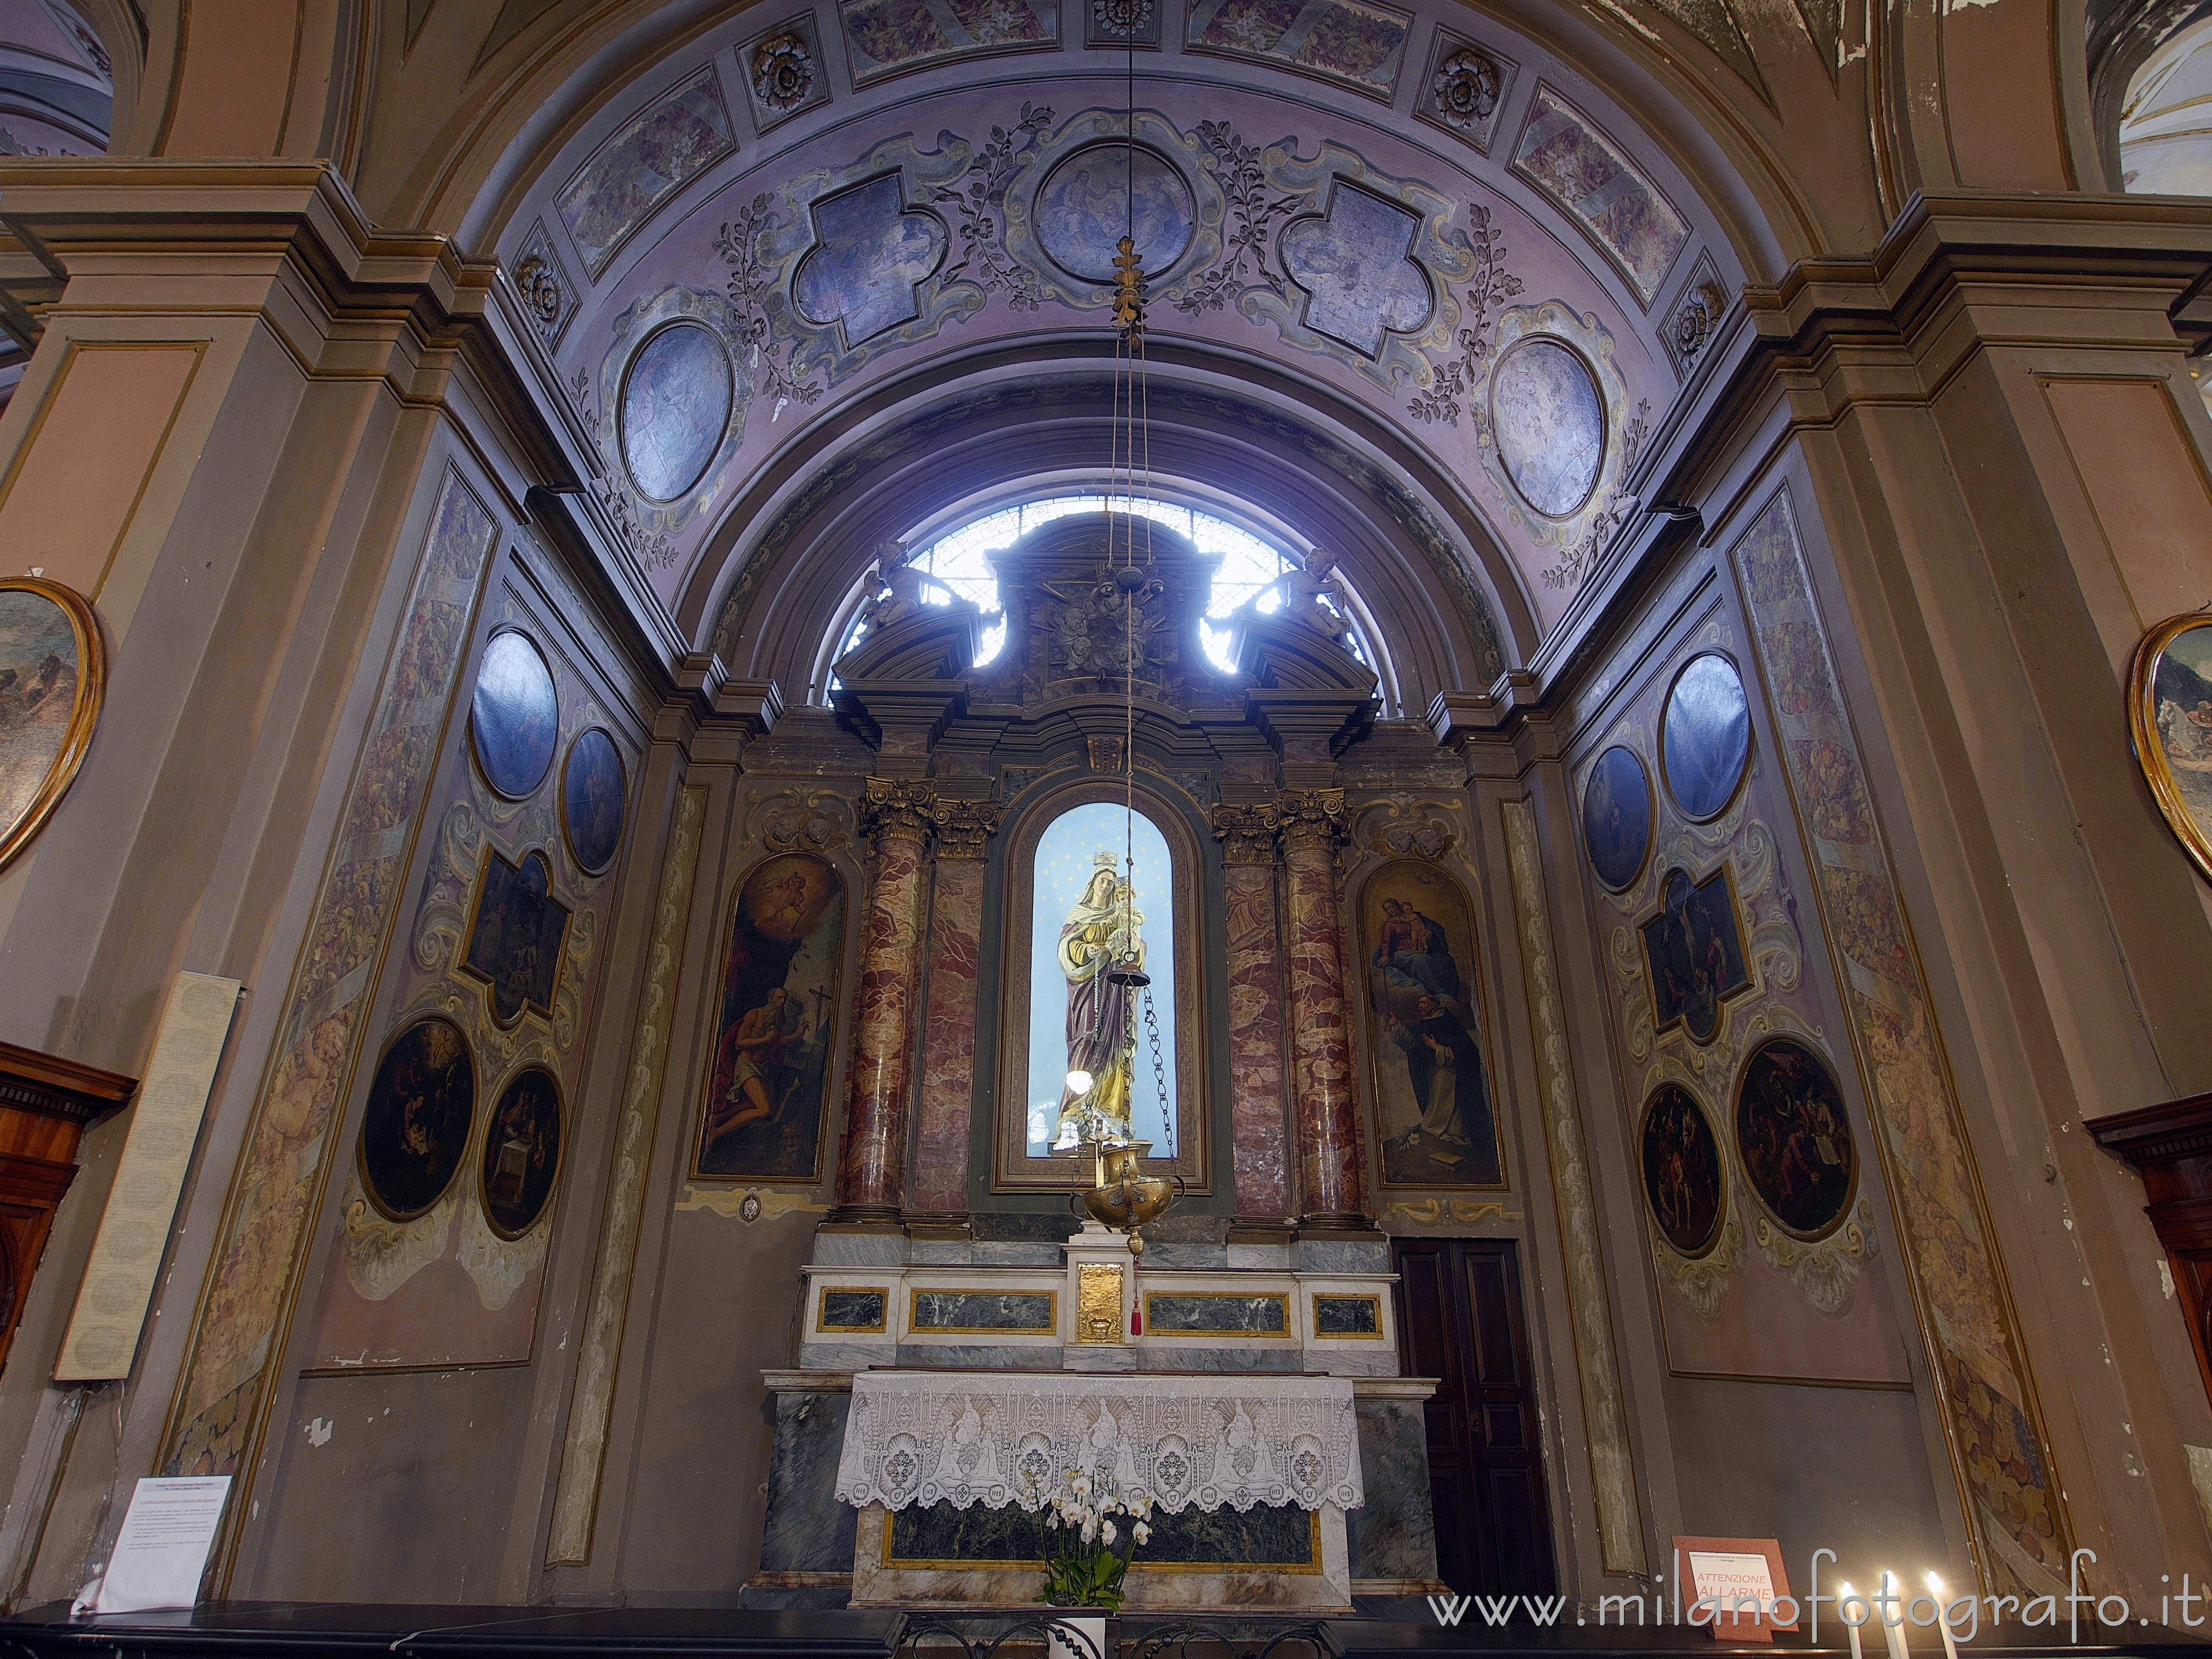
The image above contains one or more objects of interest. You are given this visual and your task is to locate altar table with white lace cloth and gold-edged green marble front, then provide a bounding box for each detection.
[836,1369,1365,1612]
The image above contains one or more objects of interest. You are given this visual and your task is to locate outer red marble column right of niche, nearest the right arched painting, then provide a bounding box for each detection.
[1274,790,1371,1227]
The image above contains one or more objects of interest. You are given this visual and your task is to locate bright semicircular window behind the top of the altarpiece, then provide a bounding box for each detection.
[821,491,1387,692]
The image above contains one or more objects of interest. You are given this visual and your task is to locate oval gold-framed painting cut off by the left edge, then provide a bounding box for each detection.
[0,575,108,869]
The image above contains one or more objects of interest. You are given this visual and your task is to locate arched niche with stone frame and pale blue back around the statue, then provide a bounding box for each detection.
[995,768,1223,1194]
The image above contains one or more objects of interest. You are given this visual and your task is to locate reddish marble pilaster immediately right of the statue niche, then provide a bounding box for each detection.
[1214,803,1289,1223]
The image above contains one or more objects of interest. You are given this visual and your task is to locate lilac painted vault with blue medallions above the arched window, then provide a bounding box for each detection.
[502,13,1734,650]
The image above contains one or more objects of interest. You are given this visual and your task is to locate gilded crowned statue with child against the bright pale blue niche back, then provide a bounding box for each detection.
[1026,801,1177,1157]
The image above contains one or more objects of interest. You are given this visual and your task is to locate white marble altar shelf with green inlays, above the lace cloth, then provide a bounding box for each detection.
[798,1234,1398,1378]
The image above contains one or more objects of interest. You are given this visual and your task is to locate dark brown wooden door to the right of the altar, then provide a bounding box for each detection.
[1391,1238,1555,1595]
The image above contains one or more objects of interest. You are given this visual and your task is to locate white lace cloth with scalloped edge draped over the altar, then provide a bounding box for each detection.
[836,1371,1367,1513]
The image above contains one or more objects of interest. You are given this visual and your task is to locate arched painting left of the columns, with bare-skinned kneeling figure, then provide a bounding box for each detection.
[692,852,845,1181]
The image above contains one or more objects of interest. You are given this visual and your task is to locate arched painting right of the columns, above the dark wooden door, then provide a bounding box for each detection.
[1360,861,1504,1188]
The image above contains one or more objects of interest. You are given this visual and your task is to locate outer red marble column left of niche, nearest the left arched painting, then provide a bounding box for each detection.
[827,779,936,1221]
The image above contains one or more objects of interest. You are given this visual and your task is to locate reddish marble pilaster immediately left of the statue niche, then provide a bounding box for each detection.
[907,798,1002,1221]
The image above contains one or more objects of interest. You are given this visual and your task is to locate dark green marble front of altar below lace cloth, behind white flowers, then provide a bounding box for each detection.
[883,1504,1321,1573]
